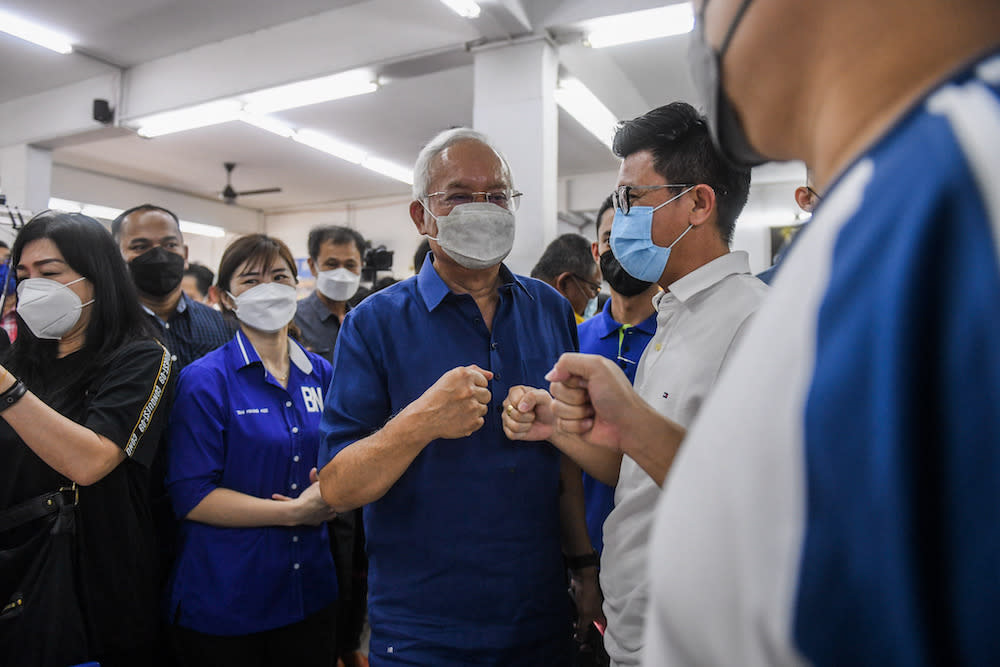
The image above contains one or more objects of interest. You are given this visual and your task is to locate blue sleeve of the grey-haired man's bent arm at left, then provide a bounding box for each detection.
[316,309,390,468]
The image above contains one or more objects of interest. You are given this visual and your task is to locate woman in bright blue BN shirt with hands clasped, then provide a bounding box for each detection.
[167,234,337,667]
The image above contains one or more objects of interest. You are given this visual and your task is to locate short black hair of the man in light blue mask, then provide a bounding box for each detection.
[614,102,750,245]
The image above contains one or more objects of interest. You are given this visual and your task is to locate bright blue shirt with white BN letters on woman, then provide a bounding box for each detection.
[167,332,337,635]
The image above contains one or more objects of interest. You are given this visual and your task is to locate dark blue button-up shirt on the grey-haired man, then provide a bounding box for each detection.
[320,259,577,665]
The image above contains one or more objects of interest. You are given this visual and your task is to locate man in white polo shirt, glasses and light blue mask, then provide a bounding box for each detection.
[504,102,766,665]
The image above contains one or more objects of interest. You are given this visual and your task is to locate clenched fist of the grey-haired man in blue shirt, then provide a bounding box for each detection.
[415,364,493,440]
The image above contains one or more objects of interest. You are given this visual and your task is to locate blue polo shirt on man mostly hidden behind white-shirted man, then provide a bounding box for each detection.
[577,299,656,553]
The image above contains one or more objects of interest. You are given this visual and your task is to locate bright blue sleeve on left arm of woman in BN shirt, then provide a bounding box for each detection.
[166,363,229,519]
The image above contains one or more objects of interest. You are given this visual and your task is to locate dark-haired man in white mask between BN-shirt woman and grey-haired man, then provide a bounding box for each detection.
[295,225,365,363]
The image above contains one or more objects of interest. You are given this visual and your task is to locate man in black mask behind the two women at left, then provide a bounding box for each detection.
[111,204,233,368]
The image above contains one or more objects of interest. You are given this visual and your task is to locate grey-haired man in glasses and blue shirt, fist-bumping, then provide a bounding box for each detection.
[319,128,596,666]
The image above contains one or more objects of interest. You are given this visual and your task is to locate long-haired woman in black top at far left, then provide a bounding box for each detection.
[0,211,175,667]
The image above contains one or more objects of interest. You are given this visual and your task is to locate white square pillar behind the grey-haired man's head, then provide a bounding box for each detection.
[473,39,559,275]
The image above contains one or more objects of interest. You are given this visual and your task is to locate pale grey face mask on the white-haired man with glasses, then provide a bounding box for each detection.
[424,202,514,269]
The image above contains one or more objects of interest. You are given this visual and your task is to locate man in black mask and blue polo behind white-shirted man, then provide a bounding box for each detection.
[577,196,660,553]
